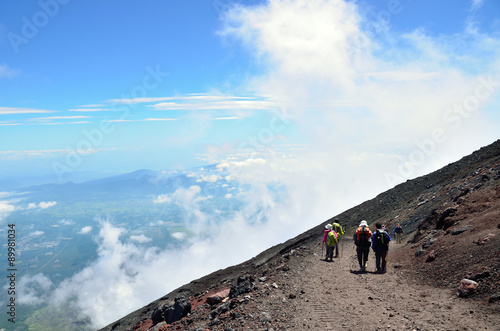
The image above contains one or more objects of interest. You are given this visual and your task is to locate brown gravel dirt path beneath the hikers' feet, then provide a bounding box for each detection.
[290,241,500,330]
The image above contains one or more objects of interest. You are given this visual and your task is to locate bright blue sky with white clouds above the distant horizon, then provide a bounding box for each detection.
[0,0,500,187]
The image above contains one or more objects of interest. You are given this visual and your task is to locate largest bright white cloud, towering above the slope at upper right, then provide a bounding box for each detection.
[221,0,500,188]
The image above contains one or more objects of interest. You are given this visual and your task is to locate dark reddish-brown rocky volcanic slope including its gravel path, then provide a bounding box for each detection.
[102,140,500,331]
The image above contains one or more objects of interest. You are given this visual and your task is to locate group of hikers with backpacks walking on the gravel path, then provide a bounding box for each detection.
[322,219,403,273]
